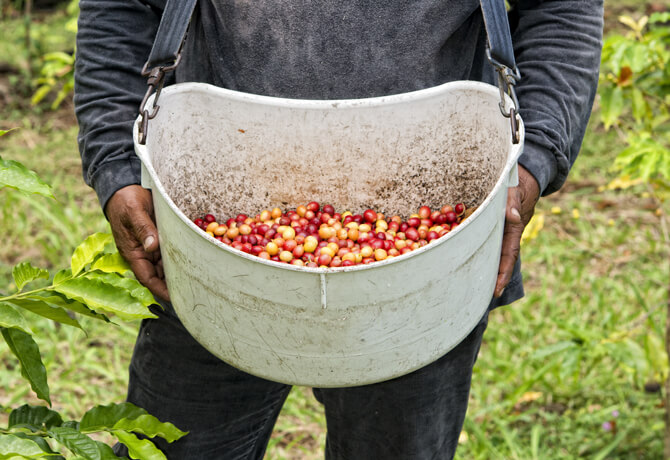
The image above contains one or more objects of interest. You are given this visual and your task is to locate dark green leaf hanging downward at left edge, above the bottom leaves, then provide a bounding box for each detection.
[2,328,51,405]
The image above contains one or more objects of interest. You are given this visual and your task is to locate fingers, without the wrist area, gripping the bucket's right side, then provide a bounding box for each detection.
[493,188,524,297]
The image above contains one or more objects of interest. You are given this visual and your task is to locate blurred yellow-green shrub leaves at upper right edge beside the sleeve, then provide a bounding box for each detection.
[600,12,670,187]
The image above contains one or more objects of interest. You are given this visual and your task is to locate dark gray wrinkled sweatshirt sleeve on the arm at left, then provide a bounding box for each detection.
[74,0,164,209]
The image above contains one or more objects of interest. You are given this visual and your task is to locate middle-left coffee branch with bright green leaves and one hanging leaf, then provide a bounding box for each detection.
[0,233,155,402]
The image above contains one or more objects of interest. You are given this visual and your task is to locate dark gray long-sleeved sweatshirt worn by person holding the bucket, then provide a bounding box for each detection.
[75,0,603,305]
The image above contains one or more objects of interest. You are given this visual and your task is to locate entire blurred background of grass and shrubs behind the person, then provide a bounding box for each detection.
[0,0,670,460]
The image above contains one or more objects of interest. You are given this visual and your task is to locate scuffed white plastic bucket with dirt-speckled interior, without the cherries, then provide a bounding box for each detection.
[135,82,523,387]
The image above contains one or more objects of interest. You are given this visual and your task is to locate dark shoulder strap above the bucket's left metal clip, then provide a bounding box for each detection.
[145,0,196,69]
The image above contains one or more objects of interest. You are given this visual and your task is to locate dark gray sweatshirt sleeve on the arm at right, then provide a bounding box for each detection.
[510,0,603,195]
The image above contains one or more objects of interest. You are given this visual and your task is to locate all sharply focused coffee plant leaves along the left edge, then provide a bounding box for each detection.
[0,149,186,460]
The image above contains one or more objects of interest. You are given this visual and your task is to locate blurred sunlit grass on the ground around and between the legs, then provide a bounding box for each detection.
[0,2,670,460]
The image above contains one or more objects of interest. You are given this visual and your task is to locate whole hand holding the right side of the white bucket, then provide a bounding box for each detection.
[493,165,540,297]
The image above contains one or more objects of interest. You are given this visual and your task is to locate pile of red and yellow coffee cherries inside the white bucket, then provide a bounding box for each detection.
[193,201,474,267]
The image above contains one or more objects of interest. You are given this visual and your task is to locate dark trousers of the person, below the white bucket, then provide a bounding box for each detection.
[116,306,488,460]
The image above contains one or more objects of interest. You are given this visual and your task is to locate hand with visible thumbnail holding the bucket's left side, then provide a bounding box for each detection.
[105,185,170,300]
